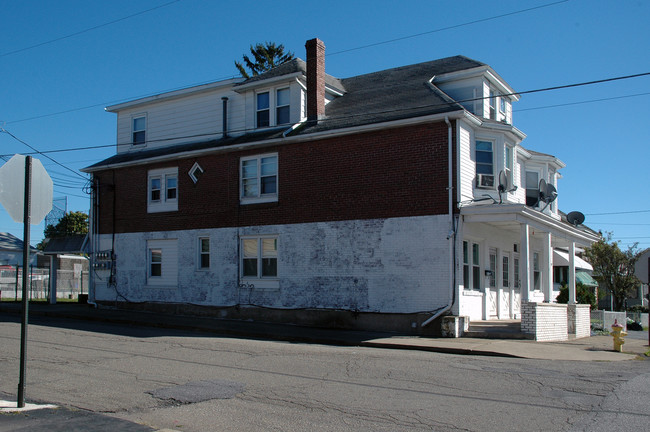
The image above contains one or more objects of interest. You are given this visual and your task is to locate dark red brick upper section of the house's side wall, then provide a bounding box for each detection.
[95,122,448,233]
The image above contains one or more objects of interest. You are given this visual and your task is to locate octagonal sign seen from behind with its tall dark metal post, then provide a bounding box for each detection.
[0,155,52,408]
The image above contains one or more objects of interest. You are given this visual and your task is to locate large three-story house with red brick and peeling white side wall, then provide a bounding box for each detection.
[84,39,598,337]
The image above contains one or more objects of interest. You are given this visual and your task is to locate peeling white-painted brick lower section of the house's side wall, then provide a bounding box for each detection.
[96,216,450,313]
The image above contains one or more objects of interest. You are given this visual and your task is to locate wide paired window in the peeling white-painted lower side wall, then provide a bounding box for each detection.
[241,236,278,279]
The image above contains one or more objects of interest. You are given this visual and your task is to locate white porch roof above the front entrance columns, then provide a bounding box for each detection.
[460,204,600,247]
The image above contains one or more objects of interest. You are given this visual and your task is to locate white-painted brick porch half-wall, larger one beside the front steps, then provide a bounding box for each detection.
[521,302,569,342]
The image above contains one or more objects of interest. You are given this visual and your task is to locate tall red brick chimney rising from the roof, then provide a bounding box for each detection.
[305,38,325,122]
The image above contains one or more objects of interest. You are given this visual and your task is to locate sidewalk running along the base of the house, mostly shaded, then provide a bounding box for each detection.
[0,302,650,361]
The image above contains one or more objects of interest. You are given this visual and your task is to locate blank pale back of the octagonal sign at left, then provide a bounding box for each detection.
[0,155,52,225]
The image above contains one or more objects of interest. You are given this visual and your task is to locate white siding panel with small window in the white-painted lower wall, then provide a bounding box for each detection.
[146,239,178,287]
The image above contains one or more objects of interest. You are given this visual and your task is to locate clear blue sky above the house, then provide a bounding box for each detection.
[0,0,650,248]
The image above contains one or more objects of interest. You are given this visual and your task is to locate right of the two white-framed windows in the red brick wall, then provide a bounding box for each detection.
[240,154,278,204]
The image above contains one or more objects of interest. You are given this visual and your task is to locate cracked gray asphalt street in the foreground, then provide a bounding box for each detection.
[0,317,650,432]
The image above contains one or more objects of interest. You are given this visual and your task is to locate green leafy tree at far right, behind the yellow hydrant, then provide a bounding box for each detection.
[585,233,641,311]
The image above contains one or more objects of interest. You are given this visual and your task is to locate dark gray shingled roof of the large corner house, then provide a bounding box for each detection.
[88,56,485,170]
